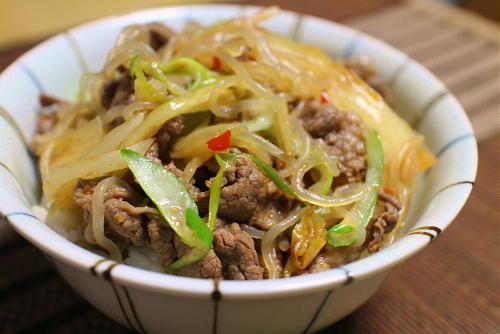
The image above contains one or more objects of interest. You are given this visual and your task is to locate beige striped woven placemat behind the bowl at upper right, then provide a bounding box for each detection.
[342,0,500,142]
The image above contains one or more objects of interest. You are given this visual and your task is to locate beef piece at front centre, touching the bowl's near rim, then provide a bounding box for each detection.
[214,223,264,280]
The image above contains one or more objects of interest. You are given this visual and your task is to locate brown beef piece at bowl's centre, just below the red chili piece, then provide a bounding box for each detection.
[218,156,286,225]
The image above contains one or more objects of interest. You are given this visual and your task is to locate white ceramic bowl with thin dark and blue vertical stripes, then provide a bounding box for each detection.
[0,5,477,333]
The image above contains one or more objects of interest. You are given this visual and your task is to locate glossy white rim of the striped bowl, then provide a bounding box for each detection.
[0,4,477,300]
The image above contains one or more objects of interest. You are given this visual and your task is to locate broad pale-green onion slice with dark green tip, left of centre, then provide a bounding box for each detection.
[120,149,212,270]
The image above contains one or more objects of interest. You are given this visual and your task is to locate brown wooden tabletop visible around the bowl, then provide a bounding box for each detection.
[0,0,500,334]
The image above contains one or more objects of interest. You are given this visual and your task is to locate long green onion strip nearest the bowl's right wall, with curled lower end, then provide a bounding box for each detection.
[326,129,384,247]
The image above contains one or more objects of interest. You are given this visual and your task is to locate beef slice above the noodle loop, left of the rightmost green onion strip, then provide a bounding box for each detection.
[301,100,366,183]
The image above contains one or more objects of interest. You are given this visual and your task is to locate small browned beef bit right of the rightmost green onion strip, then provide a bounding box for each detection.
[365,191,402,253]
